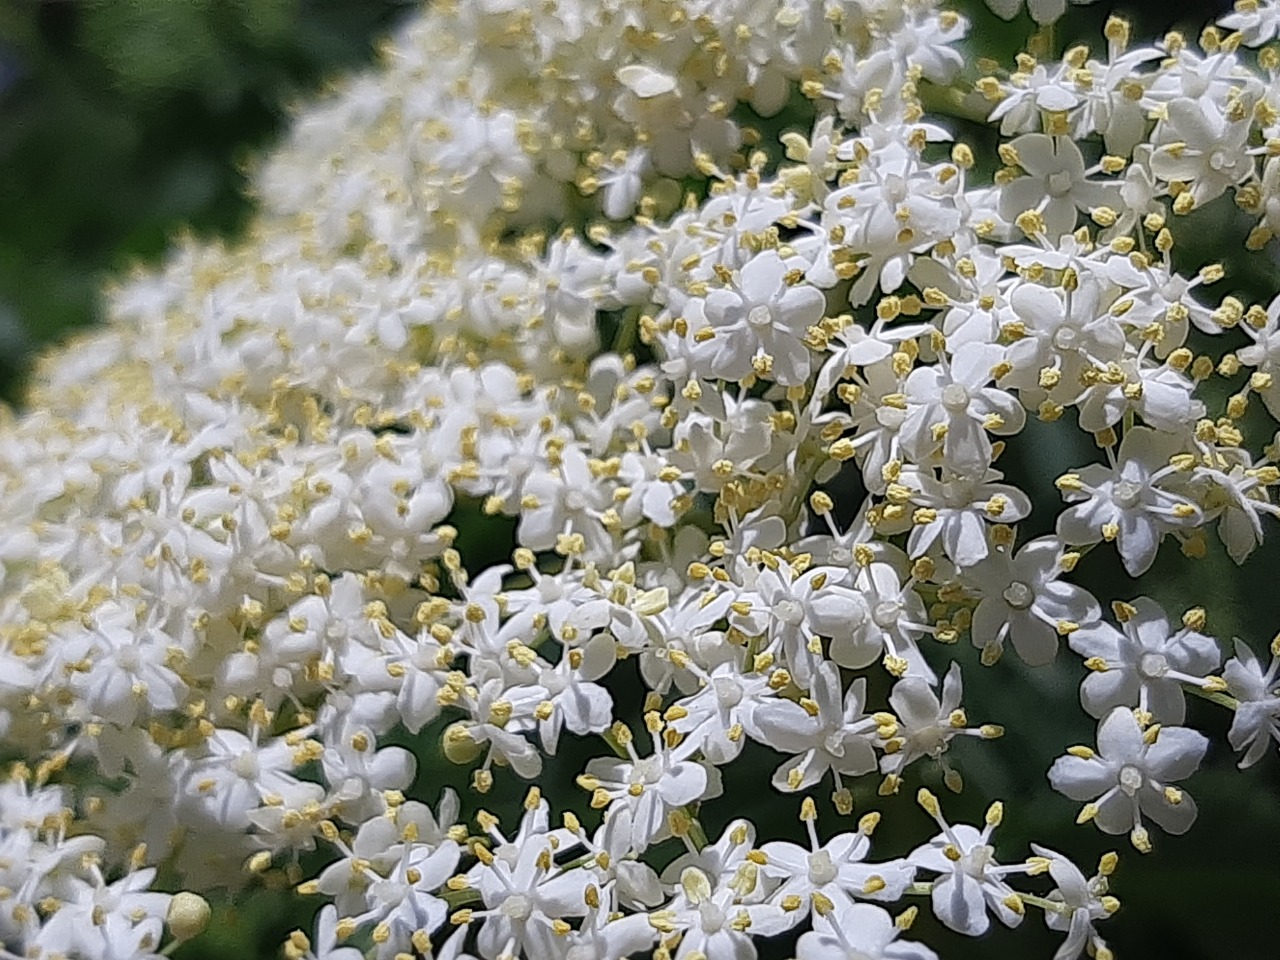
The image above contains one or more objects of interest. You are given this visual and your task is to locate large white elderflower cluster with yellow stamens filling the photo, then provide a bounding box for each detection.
[0,0,1280,960]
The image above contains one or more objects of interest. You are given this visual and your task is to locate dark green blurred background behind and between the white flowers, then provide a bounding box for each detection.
[0,0,1280,960]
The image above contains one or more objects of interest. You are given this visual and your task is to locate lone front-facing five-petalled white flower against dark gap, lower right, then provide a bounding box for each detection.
[1048,707,1208,851]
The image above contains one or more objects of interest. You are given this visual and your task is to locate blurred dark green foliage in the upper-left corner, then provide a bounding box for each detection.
[0,0,412,399]
